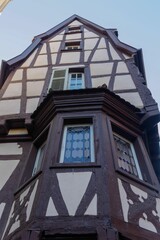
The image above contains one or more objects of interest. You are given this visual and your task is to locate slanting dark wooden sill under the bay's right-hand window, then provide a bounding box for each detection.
[116,169,159,193]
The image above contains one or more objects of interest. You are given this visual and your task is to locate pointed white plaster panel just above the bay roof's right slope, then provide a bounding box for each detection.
[117,92,143,108]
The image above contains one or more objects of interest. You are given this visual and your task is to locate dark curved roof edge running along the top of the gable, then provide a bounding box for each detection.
[0,14,145,87]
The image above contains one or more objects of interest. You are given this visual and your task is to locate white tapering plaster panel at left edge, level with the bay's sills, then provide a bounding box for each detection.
[0,160,19,190]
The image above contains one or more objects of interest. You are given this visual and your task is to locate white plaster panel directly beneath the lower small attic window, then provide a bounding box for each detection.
[60,52,80,64]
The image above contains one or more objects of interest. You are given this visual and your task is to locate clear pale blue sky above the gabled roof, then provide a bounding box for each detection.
[0,0,160,131]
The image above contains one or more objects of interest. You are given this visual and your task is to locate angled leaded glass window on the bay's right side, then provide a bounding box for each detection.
[114,134,142,179]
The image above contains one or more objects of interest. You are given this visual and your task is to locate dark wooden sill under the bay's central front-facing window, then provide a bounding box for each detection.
[50,163,101,169]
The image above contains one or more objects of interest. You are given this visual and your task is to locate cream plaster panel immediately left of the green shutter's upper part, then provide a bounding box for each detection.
[27,67,48,80]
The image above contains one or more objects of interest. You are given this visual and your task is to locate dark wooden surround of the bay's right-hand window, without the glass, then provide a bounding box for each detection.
[110,123,154,185]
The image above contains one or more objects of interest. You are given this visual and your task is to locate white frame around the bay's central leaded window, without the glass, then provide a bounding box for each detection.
[59,123,95,165]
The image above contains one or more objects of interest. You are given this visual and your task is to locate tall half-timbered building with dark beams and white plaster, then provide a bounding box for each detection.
[0,15,160,240]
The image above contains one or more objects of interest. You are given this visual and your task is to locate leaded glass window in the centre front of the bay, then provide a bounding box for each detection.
[60,125,94,163]
